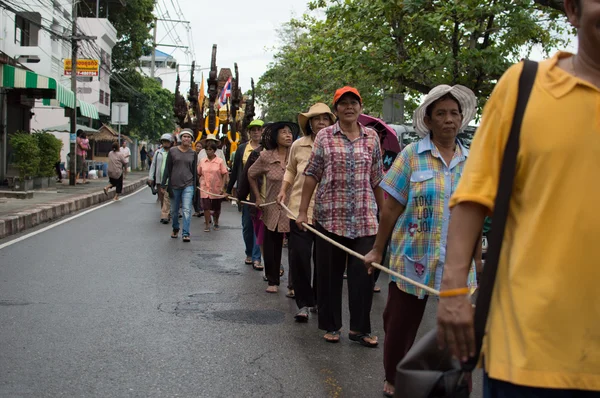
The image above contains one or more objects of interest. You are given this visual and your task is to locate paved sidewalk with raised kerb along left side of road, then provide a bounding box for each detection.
[0,171,148,239]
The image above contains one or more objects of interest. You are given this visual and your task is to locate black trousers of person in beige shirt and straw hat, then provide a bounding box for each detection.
[288,220,317,308]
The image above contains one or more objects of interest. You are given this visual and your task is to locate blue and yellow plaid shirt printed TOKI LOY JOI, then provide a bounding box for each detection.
[381,136,476,298]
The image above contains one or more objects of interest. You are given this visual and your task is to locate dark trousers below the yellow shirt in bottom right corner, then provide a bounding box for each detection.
[483,373,600,398]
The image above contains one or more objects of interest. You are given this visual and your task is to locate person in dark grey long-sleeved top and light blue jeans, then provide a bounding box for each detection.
[161,129,198,242]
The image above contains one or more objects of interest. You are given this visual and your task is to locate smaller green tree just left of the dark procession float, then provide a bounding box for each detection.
[110,69,175,141]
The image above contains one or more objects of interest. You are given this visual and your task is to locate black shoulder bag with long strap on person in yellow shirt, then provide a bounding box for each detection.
[394,60,538,398]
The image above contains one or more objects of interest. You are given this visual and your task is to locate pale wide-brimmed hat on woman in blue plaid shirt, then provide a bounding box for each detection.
[413,84,477,138]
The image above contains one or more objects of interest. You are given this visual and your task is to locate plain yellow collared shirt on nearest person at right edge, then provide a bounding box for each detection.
[450,53,600,391]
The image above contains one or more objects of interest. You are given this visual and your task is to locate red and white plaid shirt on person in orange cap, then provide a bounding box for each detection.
[304,122,383,239]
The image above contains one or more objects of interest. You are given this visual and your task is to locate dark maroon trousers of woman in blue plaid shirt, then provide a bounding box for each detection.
[383,282,429,384]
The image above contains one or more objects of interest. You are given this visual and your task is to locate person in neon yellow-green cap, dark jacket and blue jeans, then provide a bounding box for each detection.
[227,119,264,270]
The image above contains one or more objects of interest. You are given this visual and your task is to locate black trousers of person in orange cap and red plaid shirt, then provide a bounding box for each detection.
[315,223,375,333]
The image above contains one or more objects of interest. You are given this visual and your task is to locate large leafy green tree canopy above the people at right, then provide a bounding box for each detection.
[257,0,569,119]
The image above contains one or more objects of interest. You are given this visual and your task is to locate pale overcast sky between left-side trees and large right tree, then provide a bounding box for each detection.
[150,0,307,92]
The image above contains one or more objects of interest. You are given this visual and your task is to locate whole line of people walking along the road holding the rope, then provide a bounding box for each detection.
[143,6,600,398]
